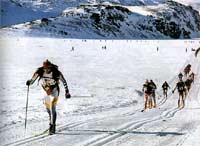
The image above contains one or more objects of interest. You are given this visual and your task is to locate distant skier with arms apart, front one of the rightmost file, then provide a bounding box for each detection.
[172,73,187,108]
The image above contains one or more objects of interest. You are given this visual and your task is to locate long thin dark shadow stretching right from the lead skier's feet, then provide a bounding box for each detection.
[56,129,185,137]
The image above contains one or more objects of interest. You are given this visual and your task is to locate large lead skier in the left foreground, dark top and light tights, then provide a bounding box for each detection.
[26,60,71,134]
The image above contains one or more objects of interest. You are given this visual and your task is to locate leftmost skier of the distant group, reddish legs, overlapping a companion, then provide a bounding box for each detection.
[142,80,153,109]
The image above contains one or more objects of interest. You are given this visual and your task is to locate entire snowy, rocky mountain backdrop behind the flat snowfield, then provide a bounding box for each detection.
[1,0,200,39]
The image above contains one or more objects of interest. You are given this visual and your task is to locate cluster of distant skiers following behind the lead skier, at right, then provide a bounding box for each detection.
[142,64,194,110]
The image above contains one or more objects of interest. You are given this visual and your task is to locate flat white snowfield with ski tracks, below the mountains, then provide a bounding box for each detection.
[0,36,200,146]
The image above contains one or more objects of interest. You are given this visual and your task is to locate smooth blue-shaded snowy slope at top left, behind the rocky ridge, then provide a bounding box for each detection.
[0,0,166,27]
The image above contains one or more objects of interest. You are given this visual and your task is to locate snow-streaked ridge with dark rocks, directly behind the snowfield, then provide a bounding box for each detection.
[2,1,200,39]
